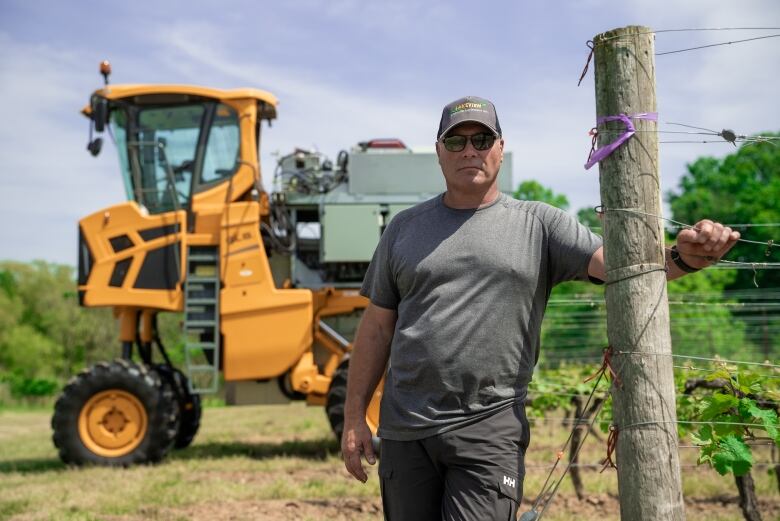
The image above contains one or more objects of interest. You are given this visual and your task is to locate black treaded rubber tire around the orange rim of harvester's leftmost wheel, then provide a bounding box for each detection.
[51,359,179,467]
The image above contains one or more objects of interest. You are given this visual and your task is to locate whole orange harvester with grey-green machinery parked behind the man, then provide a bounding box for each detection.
[52,64,511,465]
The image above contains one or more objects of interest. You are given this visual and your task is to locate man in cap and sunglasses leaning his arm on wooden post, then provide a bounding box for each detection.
[342,97,739,521]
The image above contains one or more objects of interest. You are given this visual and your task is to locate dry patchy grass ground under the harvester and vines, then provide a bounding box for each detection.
[0,404,780,521]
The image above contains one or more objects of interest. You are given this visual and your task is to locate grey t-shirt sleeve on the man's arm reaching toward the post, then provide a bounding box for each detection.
[548,204,602,285]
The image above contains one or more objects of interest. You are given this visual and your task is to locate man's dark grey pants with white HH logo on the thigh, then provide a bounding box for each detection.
[379,403,531,521]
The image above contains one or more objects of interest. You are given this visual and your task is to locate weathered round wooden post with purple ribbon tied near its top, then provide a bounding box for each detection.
[593,26,685,521]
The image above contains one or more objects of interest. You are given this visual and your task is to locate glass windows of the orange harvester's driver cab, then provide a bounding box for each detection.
[111,102,239,214]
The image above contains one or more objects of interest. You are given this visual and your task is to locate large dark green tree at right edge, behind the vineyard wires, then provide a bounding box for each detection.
[667,134,780,359]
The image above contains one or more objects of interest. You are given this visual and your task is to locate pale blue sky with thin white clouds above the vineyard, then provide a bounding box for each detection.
[0,0,780,264]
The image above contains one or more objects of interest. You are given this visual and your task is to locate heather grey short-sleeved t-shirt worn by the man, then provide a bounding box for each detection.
[360,194,601,441]
